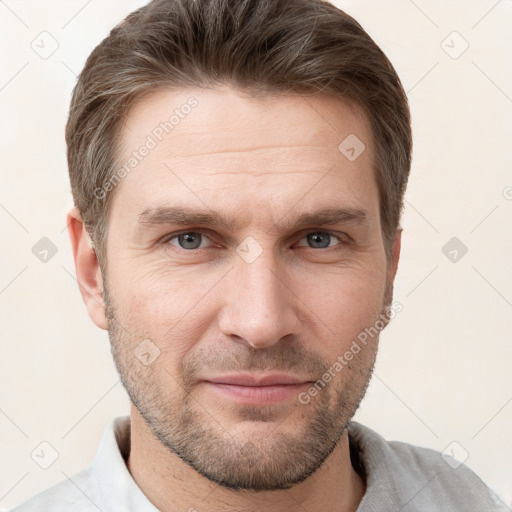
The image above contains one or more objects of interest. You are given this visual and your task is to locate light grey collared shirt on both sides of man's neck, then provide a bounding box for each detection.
[13,416,511,512]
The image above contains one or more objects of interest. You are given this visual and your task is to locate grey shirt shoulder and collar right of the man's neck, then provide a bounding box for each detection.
[349,422,509,512]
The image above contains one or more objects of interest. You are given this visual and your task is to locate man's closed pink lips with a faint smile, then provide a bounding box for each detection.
[202,374,313,405]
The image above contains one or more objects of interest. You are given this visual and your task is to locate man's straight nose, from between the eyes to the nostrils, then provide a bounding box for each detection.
[219,250,301,349]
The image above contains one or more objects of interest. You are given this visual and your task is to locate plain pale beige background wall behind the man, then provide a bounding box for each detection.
[0,0,512,509]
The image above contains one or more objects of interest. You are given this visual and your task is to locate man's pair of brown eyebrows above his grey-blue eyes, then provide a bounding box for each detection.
[137,206,368,231]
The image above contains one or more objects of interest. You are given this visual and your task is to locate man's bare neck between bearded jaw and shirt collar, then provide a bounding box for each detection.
[127,404,365,512]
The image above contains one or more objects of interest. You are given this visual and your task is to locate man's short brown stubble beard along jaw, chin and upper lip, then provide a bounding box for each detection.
[104,282,378,492]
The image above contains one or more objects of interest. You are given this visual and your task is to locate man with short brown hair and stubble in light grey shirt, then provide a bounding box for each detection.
[12,0,506,512]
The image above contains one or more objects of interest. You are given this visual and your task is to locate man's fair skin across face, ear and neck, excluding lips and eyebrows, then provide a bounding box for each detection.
[68,86,401,512]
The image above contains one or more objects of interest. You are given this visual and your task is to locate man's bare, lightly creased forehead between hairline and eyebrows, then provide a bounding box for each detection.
[113,87,377,224]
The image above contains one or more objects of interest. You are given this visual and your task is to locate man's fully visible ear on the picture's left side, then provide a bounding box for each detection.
[66,208,107,330]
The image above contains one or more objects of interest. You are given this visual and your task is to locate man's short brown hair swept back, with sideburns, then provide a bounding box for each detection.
[66,0,412,265]
